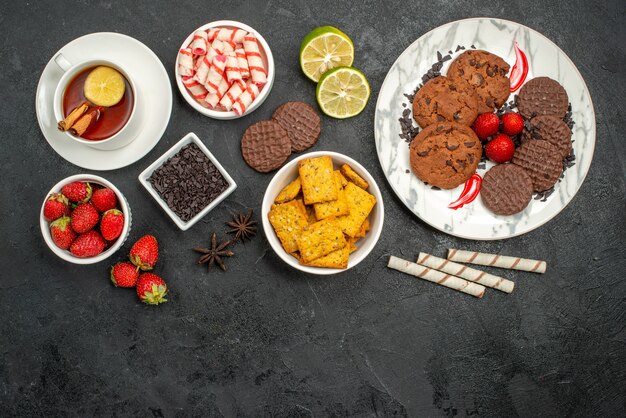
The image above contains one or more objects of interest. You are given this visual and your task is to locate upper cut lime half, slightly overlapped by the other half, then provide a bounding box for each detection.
[300,26,354,83]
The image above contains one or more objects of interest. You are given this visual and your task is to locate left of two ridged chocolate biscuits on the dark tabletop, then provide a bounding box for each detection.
[241,120,291,173]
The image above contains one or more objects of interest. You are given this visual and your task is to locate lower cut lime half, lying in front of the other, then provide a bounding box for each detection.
[315,67,370,119]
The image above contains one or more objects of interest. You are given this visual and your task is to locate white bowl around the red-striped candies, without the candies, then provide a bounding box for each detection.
[174,20,274,120]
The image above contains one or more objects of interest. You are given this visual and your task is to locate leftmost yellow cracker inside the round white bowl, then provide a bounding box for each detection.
[267,199,309,253]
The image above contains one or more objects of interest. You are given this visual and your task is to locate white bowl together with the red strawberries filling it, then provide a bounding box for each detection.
[39,174,131,264]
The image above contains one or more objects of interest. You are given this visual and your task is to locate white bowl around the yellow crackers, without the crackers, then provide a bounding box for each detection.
[261,151,385,275]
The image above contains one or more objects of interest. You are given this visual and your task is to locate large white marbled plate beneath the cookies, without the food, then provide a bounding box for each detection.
[374,18,596,240]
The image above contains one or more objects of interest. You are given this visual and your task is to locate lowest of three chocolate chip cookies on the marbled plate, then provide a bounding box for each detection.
[410,122,483,189]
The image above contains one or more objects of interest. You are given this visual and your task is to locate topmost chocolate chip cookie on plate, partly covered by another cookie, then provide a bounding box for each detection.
[448,50,511,114]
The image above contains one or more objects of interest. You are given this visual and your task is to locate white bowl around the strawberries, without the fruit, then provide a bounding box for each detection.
[39,174,132,264]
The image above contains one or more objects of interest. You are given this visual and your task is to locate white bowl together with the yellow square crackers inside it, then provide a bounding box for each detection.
[261,151,385,275]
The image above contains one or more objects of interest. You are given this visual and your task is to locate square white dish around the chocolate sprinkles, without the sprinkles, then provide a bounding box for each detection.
[139,132,237,231]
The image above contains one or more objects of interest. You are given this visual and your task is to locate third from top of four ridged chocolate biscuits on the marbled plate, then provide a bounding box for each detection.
[513,141,563,192]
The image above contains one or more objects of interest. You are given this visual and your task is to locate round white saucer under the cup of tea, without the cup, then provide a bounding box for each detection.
[35,32,172,171]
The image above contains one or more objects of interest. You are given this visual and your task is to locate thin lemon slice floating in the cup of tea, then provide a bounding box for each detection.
[83,65,126,107]
